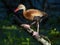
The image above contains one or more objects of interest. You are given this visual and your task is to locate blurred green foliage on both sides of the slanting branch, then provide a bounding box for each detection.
[0,15,60,45]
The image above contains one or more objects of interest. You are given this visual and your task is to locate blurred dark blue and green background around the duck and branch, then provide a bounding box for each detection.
[0,0,60,45]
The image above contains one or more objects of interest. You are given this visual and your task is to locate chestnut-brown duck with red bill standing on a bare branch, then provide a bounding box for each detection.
[14,4,47,32]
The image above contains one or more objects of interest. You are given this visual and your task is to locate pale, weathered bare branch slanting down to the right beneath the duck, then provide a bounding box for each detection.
[21,25,51,45]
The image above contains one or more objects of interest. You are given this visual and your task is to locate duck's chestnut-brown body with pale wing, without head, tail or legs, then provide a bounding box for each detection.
[24,9,43,20]
